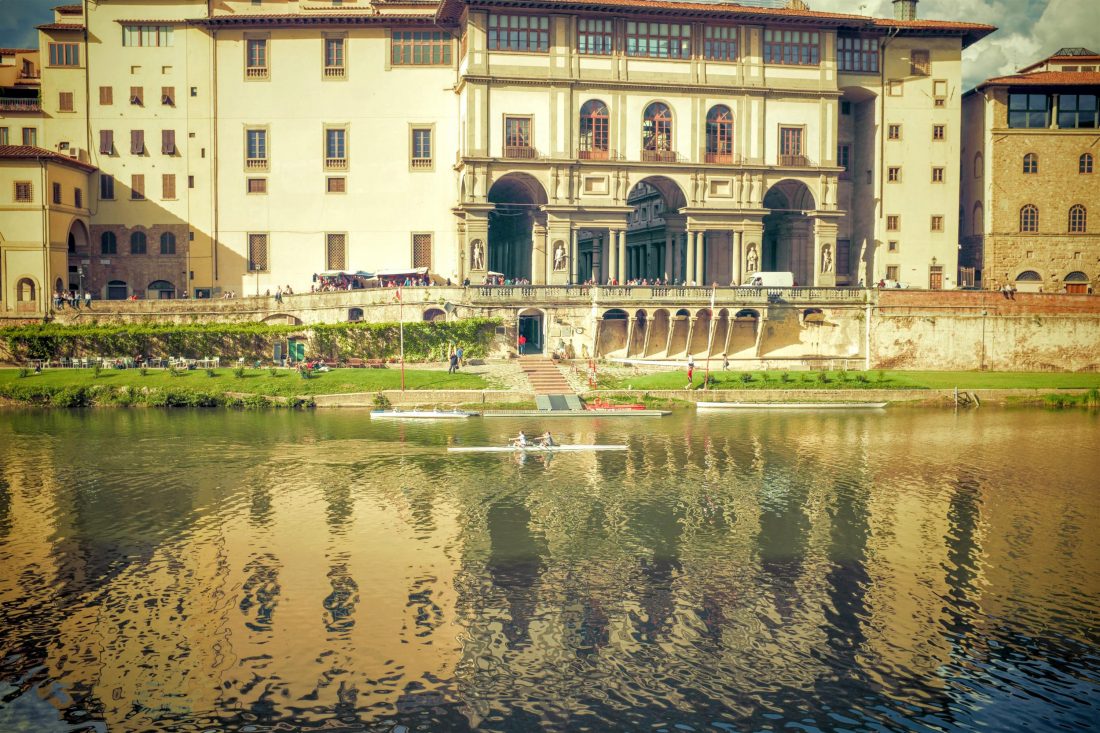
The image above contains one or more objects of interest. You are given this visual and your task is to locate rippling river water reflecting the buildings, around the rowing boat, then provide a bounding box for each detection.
[0,408,1100,732]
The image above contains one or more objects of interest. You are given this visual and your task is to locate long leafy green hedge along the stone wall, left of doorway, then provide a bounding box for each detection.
[0,318,501,362]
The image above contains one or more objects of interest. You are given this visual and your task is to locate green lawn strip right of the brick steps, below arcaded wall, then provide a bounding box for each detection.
[600,365,1100,391]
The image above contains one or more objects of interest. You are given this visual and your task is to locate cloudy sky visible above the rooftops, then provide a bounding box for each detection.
[0,0,1100,88]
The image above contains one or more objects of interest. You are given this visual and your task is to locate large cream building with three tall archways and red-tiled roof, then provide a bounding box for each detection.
[0,0,993,310]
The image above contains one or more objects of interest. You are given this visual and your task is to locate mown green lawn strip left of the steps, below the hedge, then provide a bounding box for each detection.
[0,369,491,396]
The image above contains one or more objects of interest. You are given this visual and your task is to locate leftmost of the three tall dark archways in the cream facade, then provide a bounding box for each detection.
[488,173,547,281]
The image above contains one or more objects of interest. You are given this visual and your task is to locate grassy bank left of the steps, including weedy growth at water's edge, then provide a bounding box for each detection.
[0,369,491,407]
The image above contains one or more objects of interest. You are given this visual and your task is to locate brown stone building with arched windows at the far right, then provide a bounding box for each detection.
[960,48,1100,293]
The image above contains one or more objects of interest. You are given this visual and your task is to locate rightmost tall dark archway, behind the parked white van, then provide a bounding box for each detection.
[760,179,817,285]
